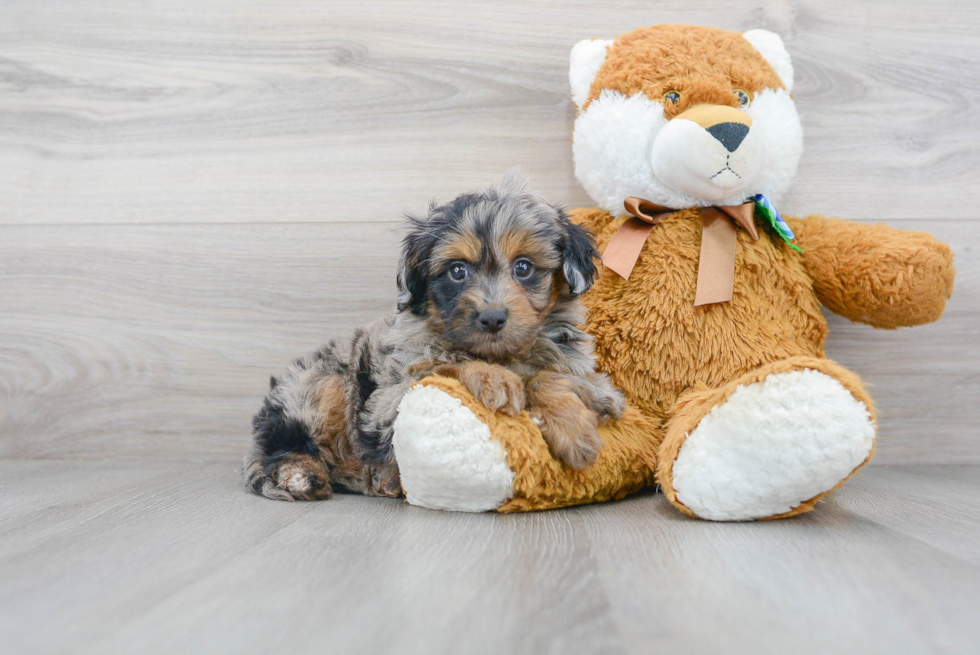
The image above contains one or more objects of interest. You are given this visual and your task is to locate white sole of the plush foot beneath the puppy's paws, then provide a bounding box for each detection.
[392,386,514,512]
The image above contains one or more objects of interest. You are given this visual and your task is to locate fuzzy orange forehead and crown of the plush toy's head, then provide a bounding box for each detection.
[583,25,784,118]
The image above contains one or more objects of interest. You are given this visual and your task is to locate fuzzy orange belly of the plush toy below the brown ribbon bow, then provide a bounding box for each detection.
[583,210,827,419]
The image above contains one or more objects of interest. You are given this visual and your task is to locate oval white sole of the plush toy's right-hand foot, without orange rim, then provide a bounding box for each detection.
[673,369,875,521]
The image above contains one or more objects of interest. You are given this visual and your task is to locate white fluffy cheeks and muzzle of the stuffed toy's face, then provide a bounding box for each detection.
[572,89,803,214]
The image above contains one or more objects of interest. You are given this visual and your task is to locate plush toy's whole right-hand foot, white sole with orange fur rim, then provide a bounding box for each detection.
[658,357,875,521]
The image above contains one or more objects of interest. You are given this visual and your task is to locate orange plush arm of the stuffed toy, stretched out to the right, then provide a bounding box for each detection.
[786,216,955,329]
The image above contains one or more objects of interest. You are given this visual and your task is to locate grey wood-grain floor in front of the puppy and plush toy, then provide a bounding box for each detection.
[0,461,980,655]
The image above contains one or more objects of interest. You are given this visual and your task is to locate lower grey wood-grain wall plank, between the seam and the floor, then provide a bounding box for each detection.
[0,221,980,464]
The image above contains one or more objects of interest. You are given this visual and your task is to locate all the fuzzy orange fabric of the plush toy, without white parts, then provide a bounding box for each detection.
[402,25,954,518]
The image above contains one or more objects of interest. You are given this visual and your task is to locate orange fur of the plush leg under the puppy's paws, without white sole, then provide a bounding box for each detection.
[414,375,662,512]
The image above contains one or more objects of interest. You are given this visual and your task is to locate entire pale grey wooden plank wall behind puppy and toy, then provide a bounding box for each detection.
[0,0,980,464]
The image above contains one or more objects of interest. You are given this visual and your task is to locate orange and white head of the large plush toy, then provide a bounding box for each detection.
[569,25,803,214]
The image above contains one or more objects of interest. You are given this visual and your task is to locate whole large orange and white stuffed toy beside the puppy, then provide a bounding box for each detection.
[386,25,954,521]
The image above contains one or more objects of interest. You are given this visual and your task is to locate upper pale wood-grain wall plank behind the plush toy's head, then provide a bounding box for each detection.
[0,0,980,224]
